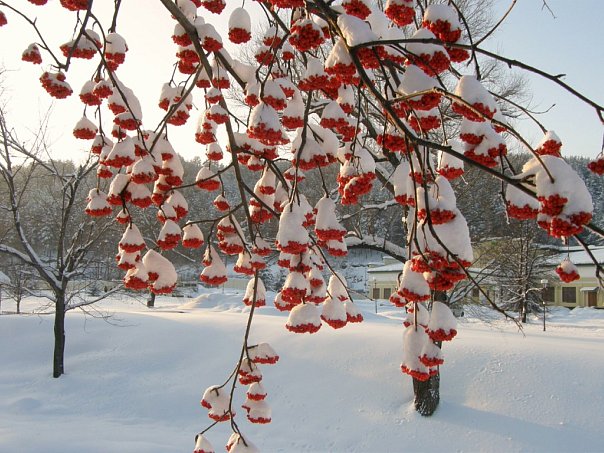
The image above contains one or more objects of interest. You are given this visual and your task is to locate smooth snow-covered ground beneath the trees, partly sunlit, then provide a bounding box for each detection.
[0,293,604,453]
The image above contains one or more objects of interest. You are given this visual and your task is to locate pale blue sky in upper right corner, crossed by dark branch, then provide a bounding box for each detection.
[490,0,604,158]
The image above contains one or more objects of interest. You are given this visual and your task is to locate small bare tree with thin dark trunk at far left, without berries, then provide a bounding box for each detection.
[0,104,110,378]
